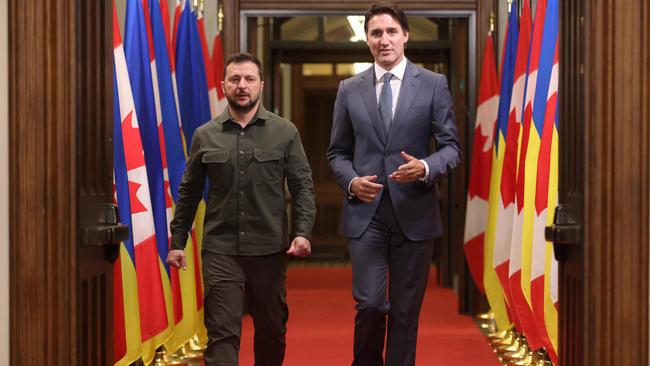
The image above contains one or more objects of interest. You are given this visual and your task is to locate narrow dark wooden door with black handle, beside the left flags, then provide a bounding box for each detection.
[73,0,123,365]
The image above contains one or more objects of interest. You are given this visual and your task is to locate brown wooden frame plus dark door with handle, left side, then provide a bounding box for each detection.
[9,0,119,365]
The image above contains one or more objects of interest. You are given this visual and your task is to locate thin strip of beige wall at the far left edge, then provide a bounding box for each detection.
[0,0,9,365]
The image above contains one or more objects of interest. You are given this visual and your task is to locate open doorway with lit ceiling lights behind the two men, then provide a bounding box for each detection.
[240,11,475,280]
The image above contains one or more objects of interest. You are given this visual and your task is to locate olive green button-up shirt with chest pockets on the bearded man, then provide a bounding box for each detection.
[170,105,316,255]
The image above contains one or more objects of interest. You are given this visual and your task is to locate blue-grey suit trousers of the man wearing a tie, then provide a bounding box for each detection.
[349,191,433,366]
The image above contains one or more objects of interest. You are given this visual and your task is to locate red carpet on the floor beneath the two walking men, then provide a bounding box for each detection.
[240,267,500,366]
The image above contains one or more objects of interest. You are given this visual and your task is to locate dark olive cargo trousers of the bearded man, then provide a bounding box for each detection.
[203,252,289,366]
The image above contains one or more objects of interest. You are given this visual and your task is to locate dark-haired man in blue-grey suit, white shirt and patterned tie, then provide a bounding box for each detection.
[327,3,460,366]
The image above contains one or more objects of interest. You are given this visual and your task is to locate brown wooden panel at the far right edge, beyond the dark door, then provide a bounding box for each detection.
[576,0,650,366]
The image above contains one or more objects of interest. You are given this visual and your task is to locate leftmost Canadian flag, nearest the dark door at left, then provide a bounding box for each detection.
[113,2,169,362]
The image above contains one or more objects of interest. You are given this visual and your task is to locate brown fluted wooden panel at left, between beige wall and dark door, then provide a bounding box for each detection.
[9,0,76,365]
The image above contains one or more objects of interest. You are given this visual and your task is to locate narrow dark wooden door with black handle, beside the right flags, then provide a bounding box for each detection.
[547,1,587,366]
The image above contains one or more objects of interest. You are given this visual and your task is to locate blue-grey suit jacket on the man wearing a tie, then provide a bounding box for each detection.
[327,61,460,241]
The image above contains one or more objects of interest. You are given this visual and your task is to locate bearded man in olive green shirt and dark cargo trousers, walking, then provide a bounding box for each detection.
[167,53,316,366]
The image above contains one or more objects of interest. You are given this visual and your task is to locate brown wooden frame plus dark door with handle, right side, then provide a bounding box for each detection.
[547,0,650,366]
